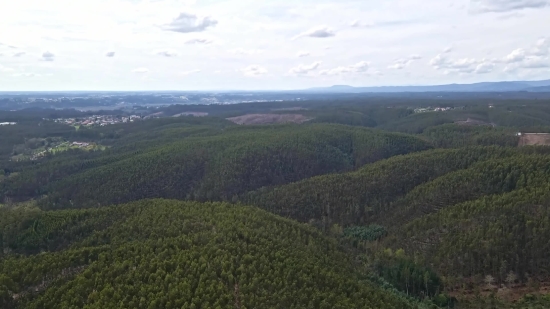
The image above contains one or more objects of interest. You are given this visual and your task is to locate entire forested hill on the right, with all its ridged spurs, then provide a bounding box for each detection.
[243,147,550,289]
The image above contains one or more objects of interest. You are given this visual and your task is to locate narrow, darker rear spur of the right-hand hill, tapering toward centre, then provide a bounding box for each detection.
[242,147,517,226]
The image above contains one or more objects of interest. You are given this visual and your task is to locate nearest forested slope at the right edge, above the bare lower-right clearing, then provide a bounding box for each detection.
[396,184,550,286]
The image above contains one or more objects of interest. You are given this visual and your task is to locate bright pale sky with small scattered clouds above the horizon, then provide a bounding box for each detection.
[0,0,550,91]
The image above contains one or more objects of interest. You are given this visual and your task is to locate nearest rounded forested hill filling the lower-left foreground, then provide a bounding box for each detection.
[0,200,417,309]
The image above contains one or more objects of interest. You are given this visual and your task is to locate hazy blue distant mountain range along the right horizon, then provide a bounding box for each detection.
[299,80,550,93]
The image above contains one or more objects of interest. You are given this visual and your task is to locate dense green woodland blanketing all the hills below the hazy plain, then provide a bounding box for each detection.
[0,98,550,308]
